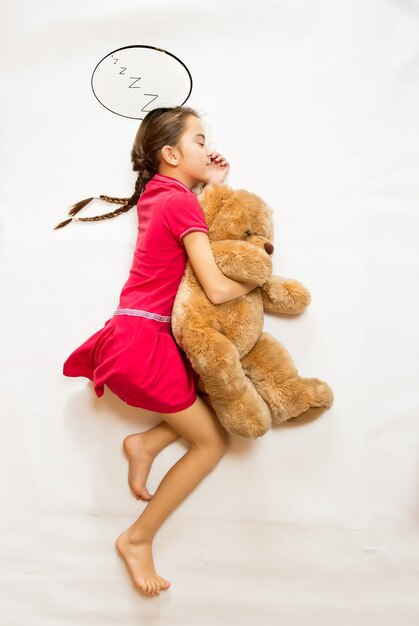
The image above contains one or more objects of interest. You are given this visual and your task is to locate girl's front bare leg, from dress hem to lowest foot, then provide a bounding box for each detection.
[116,396,228,595]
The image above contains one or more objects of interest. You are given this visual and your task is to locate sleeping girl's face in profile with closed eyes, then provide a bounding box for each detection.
[162,115,211,187]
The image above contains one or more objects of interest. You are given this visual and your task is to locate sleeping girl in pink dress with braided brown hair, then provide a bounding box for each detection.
[55,106,257,595]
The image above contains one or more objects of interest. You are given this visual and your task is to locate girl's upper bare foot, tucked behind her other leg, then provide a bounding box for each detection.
[123,433,154,500]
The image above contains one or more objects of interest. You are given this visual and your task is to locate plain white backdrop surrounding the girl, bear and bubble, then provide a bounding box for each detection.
[0,0,419,626]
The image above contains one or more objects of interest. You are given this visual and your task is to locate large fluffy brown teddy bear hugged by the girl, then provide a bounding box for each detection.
[172,183,333,439]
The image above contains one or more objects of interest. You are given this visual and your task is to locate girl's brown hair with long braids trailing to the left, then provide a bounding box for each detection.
[53,106,199,230]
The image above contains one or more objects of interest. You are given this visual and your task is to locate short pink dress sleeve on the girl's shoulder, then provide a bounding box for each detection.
[164,193,209,245]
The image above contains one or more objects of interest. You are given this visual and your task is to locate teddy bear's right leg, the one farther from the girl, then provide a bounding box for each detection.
[242,333,333,424]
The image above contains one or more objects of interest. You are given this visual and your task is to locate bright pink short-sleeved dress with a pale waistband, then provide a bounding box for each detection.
[63,174,208,413]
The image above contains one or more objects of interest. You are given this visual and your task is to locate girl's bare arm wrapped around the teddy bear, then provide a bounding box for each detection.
[183,231,259,304]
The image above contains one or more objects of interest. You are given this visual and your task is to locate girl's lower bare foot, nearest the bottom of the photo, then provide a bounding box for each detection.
[115,528,170,596]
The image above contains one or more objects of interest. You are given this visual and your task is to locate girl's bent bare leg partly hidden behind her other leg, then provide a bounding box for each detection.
[123,420,180,500]
